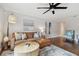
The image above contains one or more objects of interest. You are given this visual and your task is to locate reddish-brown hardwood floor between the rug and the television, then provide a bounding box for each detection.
[48,37,79,56]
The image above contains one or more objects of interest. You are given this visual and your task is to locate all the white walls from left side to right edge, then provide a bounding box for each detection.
[4,8,79,44]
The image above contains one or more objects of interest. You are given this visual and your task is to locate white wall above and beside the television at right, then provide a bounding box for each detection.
[65,16,79,42]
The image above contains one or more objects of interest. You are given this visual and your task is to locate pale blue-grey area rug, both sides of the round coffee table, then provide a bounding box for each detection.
[1,45,76,56]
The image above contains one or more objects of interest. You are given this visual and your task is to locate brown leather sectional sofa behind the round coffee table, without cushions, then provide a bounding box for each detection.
[10,33,52,50]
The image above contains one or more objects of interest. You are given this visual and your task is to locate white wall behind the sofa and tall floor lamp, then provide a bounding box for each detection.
[4,11,45,35]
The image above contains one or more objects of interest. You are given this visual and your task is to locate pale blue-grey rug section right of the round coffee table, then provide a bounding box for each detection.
[40,45,77,56]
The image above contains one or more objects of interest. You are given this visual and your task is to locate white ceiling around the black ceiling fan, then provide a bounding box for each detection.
[0,3,79,19]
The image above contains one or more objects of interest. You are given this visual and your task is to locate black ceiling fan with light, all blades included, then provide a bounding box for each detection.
[37,3,67,14]
